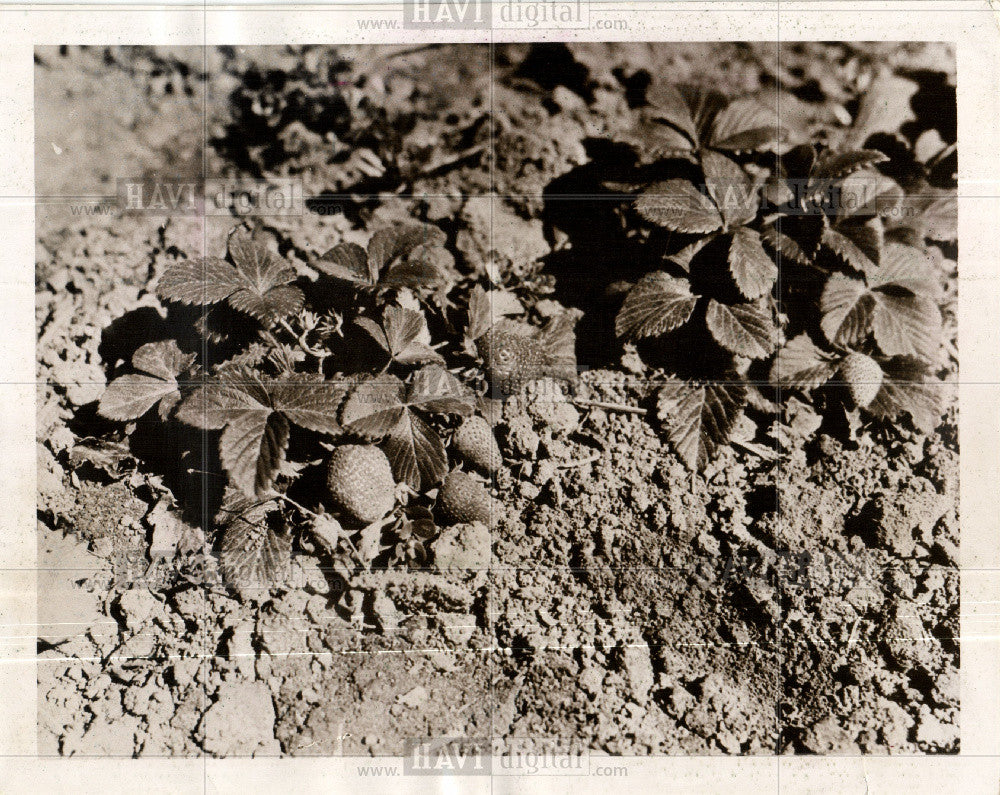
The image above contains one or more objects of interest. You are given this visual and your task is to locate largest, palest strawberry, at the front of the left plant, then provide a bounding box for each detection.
[326,444,396,524]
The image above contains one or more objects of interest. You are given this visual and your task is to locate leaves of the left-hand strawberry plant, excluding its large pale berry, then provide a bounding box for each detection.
[98,223,492,585]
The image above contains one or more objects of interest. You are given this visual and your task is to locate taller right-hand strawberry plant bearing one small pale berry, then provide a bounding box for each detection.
[615,77,955,469]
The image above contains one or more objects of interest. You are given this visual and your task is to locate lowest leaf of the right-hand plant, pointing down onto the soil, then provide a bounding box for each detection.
[656,381,746,471]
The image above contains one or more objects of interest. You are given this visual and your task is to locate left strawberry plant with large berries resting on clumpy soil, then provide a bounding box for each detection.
[98,224,532,589]
